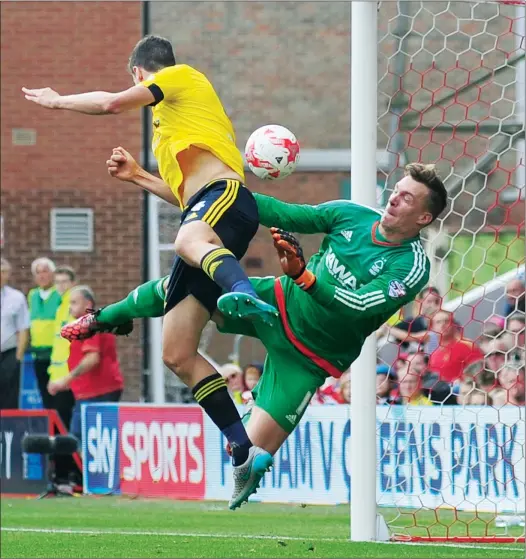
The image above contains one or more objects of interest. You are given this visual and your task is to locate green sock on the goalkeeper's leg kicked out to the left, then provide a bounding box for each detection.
[97,278,164,326]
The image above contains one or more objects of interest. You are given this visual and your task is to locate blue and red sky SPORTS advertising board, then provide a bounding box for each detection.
[84,406,205,498]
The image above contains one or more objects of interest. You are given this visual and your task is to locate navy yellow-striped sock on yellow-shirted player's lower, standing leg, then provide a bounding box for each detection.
[192,373,252,466]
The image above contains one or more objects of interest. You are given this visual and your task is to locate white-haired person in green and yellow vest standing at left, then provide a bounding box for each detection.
[27,258,61,409]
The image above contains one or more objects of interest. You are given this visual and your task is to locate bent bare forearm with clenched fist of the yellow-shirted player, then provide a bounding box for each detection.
[106,147,179,206]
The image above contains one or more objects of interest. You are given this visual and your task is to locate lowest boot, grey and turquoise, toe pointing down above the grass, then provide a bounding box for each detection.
[228,446,274,510]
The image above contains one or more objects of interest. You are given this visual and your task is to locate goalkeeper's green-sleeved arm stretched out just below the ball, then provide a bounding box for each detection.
[254,193,341,233]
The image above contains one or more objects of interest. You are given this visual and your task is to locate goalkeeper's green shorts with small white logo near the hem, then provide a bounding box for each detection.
[219,277,328,433]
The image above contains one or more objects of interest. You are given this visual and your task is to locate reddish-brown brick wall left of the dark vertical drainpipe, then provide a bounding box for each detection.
[1,2,143,399]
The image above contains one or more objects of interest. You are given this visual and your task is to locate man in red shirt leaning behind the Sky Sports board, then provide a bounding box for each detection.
[48,285,124,440]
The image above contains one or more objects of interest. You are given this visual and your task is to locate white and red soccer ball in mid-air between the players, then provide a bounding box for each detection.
[245,124,300,180]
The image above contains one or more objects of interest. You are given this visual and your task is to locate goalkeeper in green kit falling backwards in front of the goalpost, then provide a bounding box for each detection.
[63,155,447,508]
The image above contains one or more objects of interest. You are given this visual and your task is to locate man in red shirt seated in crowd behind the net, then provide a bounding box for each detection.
[428,311,484,383]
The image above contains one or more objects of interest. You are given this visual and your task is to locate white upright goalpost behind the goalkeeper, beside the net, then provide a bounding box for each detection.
[350,2,384,541]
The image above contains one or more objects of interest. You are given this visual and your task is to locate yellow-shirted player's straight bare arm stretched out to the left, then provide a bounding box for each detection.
[22,85,155,115]
